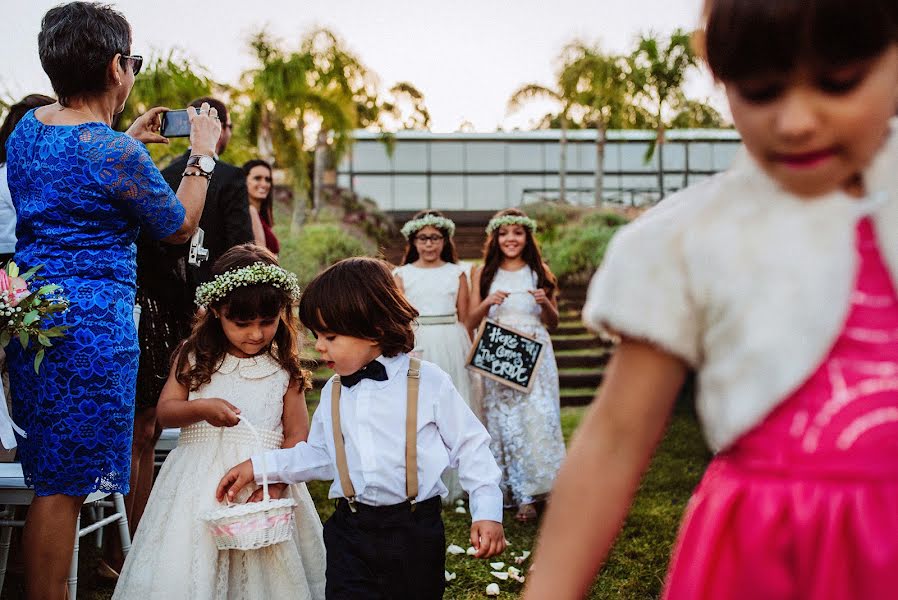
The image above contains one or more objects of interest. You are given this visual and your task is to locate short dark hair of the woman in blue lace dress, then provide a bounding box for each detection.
[37,2,131,106]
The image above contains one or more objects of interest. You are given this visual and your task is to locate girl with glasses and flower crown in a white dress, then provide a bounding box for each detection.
[393,210,480,503]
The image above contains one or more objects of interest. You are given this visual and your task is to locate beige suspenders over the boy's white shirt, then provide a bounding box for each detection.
[331,358,421,512]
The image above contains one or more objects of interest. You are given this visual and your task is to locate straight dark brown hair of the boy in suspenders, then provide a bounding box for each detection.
[299,257,418,356]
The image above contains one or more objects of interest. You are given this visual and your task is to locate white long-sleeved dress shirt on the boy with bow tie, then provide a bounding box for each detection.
[252,354,502,523]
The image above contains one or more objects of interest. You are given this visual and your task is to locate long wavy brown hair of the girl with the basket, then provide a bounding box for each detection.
[175,244,311,390]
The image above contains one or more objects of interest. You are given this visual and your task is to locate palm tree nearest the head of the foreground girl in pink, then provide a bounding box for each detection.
[629,29,697,198]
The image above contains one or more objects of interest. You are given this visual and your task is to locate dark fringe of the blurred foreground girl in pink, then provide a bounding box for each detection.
[697,0,898,81]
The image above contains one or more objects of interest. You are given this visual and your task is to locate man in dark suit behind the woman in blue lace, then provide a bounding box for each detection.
[162,98,254,288]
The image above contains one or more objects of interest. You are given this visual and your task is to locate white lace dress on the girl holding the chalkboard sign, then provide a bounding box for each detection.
[483,267,564,506]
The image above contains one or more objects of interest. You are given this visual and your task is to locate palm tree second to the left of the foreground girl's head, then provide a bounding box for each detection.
[559,42,628,206]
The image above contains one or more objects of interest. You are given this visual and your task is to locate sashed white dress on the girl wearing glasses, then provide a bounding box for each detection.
[393,263,481,504]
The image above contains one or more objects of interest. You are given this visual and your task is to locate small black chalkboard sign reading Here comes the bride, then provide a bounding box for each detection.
[465,319,543,392]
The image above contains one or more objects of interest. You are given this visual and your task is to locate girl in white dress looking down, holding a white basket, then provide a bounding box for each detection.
[113,244,325,600]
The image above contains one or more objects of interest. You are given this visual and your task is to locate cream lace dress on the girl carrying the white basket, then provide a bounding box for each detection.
[113,354,325,600]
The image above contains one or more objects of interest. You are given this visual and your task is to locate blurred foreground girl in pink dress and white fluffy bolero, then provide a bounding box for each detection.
[525,0,898,600]
